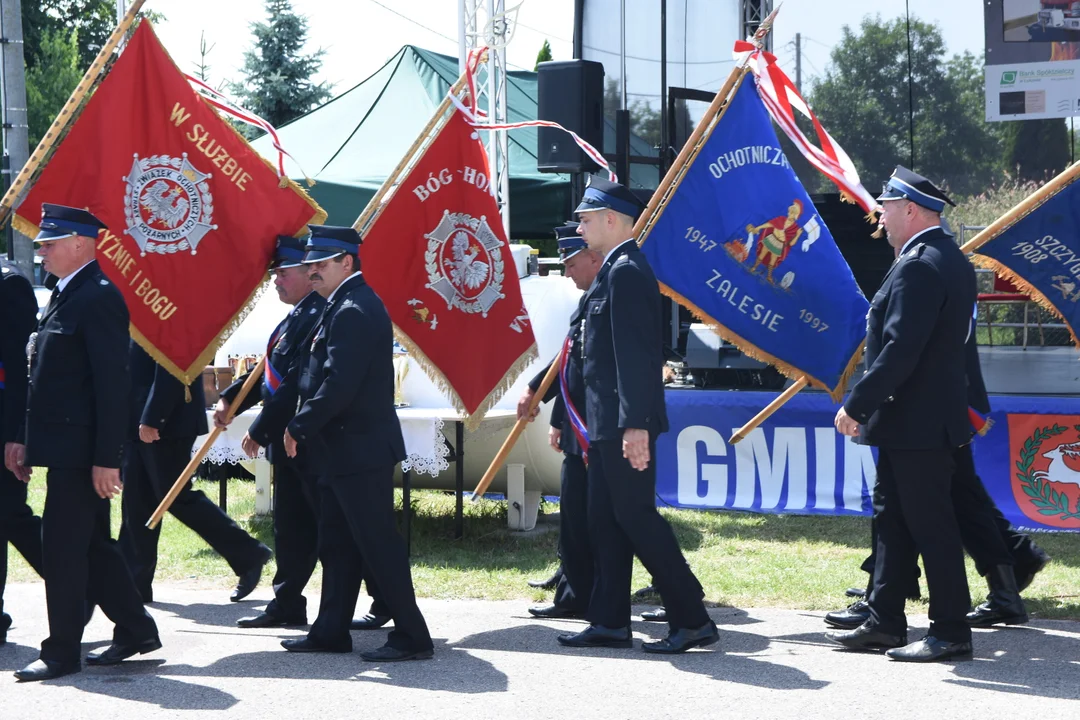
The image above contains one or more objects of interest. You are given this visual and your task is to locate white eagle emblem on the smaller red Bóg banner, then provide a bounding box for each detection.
[423,210,505,317]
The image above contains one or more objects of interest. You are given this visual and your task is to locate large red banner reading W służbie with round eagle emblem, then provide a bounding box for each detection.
[14,21,326,383]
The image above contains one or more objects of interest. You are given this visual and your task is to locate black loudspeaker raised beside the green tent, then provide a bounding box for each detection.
[537,60,604,173]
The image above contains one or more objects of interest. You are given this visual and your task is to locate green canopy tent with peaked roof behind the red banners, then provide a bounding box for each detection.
[253,45,656,240]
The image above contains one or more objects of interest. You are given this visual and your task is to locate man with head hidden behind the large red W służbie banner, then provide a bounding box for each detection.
[119,340,273,602]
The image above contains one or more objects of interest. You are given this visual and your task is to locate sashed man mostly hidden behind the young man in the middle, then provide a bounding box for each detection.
[517,222,604,617]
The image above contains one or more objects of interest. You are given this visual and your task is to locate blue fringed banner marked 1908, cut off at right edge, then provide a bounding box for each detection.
[974,181,1080,345]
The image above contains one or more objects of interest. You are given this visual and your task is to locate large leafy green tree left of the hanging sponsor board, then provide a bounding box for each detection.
[808,16,1002,194]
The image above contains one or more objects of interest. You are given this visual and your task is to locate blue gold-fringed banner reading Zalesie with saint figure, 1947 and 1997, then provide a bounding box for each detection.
[642,74,869,397]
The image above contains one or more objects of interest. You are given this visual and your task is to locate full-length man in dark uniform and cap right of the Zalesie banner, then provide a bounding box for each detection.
[826,167,976,662]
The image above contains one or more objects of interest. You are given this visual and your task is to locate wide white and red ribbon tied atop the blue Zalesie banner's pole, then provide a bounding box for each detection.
[733,40,880,214]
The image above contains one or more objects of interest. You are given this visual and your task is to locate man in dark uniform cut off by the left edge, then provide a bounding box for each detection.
[0,259,41,646]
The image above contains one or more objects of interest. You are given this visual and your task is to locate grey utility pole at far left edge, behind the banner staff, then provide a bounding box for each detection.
[0,0,33,276]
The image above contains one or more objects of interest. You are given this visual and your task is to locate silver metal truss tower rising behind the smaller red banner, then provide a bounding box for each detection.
[458,0,521,239]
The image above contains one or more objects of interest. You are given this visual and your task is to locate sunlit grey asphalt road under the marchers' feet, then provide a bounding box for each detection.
[0,581,1080,720]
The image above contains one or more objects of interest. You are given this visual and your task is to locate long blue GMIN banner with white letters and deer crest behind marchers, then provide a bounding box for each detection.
[657,389,1080,532]
